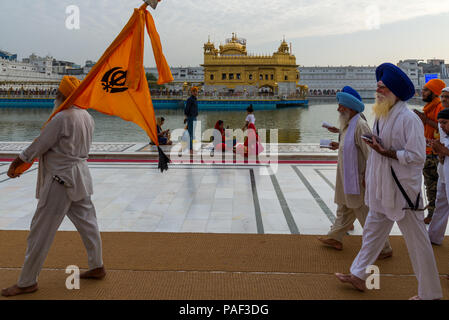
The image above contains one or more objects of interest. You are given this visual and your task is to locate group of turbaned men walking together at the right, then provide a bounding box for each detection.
[318,63,449,300]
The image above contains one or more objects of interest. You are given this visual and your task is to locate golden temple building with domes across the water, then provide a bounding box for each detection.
[202,33,301,96]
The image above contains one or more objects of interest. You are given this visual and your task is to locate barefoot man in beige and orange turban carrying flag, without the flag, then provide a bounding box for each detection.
[2,76,106,297]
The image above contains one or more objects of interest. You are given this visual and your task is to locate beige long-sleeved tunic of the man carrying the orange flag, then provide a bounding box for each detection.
[19,107,95,201]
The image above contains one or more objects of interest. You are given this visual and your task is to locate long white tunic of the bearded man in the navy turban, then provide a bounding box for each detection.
[365,101,426,221]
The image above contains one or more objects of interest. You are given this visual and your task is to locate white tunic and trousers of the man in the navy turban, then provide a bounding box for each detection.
[351,101,442,300]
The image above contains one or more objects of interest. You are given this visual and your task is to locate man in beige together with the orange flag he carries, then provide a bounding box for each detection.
[2,0,173,297]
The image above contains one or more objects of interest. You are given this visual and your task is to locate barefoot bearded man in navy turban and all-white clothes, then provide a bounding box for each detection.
[336,63,443,300]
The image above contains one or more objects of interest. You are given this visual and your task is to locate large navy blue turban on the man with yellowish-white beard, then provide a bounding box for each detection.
[376,63,415,101]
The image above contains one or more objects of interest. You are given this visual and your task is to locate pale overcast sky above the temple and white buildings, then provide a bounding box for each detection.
[0,0,449,67]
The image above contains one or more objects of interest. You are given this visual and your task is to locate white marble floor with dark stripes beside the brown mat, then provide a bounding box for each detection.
[0,162,440,235]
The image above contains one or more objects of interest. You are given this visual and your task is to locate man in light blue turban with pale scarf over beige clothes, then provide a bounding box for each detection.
[318,87,392,259]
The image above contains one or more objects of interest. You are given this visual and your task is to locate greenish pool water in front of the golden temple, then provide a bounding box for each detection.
[0,101,417,143]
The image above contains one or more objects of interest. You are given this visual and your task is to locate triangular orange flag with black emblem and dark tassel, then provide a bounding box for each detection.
[47,4,173,171]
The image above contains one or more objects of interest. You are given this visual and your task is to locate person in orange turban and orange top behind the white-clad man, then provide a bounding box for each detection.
[415,79,446,224]
